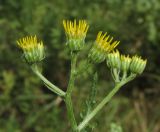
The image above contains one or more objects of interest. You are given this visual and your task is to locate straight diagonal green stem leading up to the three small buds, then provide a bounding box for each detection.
[77,75,135,131]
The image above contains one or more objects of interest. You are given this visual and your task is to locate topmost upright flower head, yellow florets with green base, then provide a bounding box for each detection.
[63,20,89,51]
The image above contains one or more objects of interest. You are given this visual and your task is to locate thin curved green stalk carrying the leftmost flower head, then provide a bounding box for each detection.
[31,66,66,97]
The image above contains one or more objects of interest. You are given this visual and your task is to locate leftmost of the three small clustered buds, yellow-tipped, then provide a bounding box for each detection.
[107,50,121,69]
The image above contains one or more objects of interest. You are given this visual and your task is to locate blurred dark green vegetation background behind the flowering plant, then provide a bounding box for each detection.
[0,0,160,132]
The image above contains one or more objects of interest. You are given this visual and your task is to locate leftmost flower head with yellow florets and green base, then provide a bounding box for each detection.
[17,36,45,64]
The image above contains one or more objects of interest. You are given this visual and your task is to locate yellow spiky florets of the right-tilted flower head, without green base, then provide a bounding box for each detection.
[96,31,120,53]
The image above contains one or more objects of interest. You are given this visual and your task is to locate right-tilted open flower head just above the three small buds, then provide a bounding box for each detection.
[88,31,119,63]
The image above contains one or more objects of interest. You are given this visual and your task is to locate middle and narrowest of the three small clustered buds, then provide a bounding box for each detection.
[121,55,131,72]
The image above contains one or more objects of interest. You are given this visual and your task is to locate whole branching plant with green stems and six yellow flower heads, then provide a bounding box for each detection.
[17,20,147,132]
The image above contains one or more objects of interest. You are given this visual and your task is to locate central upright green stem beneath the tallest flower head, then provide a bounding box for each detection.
[65,53,77,131]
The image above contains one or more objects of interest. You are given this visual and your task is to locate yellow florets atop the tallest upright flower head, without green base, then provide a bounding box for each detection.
[63,20,89,39]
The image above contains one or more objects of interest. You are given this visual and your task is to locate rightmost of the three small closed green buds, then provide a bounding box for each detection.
[130,56,147,74]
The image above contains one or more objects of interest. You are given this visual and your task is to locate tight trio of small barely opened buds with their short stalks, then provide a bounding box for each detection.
[107,50,147,82]
